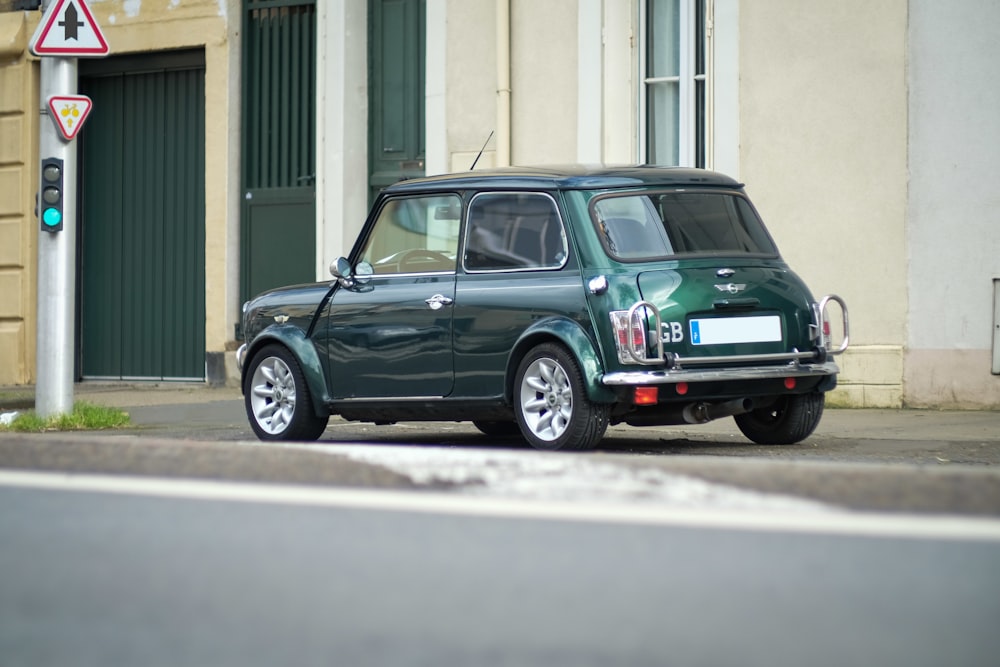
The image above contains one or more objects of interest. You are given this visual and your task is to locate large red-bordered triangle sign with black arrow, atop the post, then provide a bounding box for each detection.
[30,0,109,58]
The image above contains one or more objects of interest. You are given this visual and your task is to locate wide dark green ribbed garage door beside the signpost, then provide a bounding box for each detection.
[77,50,205,380]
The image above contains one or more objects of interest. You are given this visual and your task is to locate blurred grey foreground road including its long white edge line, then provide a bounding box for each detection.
[0,476,1000,667]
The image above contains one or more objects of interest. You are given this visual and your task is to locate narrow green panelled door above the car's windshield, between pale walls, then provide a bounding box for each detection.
[368,0,427,202]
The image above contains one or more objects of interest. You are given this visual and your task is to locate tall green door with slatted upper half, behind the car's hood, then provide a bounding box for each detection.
[241,0,316,299]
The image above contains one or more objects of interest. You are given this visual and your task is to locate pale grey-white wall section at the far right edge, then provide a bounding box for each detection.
[906,0,1000,408]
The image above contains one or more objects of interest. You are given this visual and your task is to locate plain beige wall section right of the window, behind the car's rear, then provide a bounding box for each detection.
[739,0,907,407]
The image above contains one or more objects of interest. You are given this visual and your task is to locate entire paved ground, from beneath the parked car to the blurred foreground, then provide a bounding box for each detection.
[0,388,1000,667]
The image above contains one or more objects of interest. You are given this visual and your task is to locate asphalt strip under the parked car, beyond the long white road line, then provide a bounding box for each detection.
[0,385,1000,516]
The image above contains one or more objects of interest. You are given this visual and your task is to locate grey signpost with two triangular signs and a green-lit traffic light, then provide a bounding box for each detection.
[29,0,109,418]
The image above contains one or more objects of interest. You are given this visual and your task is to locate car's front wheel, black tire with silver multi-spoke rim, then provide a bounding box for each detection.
[243,345,330,440]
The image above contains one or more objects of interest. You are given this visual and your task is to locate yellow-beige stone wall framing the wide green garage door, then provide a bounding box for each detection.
[0,0,240,385]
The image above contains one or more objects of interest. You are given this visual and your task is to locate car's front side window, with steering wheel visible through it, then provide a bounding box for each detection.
[360,194,462,275]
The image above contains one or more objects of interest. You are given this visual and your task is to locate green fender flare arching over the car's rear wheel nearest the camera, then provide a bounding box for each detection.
[505,317,615,403]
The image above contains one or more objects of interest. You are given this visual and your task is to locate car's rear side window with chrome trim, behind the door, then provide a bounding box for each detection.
[464,192,567,272]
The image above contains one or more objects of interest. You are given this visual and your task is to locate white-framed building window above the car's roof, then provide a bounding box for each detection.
[640,0,708,167]
